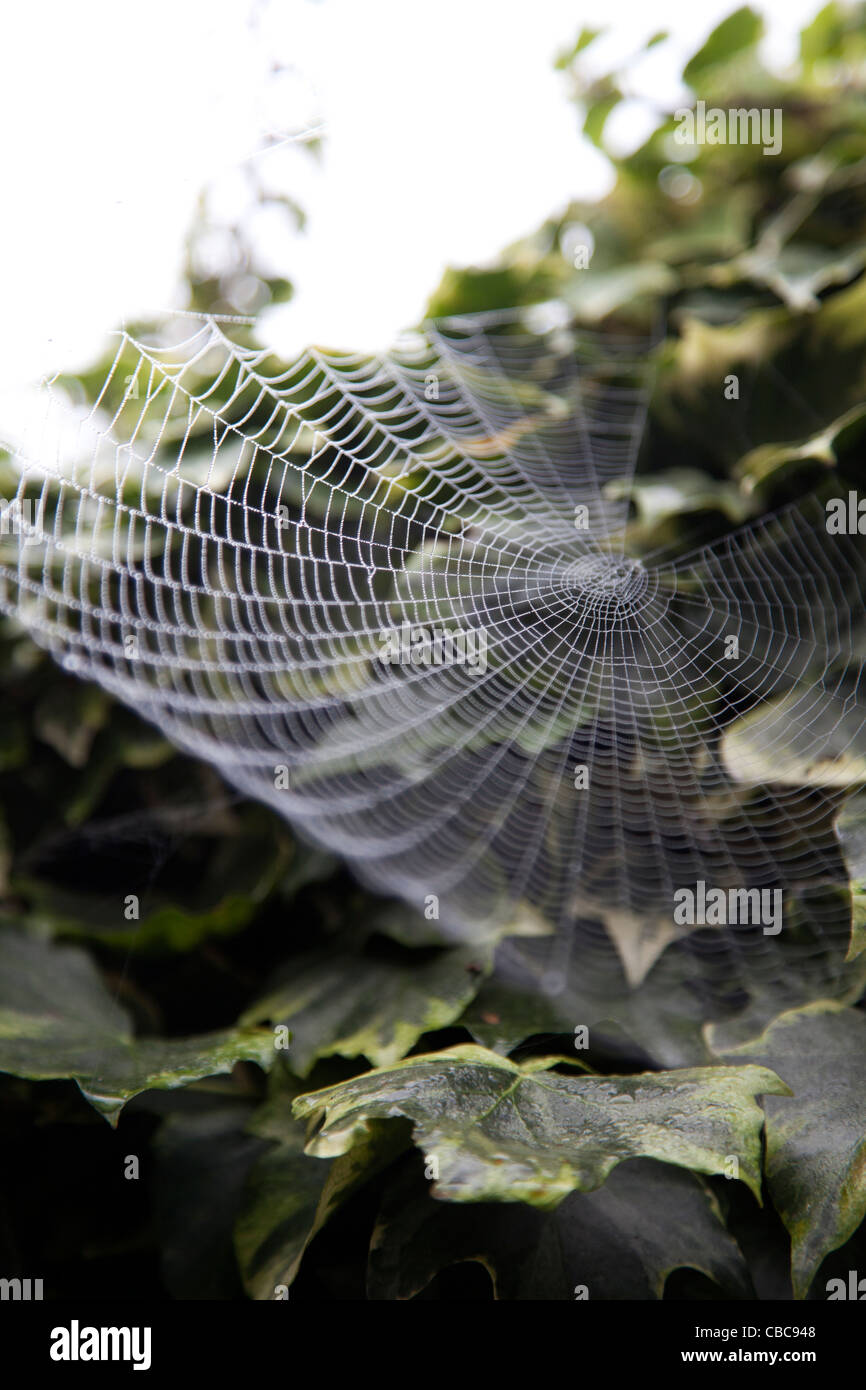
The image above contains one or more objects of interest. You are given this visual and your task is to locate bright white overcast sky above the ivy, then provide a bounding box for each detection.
[0,0,819,400]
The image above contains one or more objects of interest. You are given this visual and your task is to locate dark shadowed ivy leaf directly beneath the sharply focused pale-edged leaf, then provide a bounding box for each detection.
[367,1158,753,1301]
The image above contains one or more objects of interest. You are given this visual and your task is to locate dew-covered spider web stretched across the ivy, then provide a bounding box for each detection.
[0,306,866,1023]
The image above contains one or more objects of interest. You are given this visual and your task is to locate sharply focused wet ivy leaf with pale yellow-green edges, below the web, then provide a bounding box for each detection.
[295,1045,781,1207]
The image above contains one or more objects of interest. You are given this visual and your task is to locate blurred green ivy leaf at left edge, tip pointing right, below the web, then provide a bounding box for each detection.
[0,931,274,1125]
